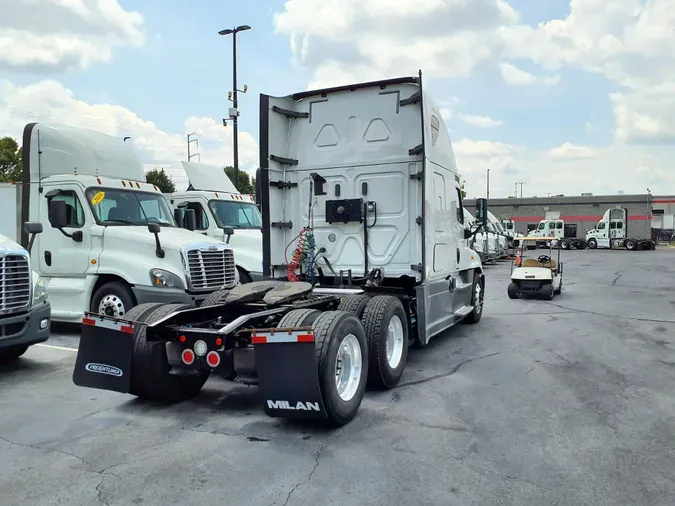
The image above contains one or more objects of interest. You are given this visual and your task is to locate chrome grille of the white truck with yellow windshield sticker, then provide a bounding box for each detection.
[187,249,236,290]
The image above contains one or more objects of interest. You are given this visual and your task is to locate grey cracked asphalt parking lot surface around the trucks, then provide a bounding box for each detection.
[0,247,675,506]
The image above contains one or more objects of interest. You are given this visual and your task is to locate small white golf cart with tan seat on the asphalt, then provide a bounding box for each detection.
[507,237,563,300]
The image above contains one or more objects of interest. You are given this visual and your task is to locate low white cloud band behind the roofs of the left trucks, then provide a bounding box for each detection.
[0,80,258,189]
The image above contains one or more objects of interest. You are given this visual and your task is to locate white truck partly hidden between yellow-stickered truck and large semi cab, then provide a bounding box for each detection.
[170,162,262,283]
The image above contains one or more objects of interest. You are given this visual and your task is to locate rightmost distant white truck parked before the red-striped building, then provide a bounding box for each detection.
[586,207,656,251]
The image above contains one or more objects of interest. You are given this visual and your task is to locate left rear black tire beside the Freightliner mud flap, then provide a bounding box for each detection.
[130,304,210,403]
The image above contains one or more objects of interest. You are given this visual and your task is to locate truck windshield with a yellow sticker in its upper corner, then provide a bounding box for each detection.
[87,188,176,227]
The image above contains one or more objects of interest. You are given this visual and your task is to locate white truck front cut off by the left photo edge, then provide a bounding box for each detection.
[0,218,51,364]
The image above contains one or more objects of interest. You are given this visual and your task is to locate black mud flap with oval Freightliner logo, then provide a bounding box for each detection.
[73,314,134,393]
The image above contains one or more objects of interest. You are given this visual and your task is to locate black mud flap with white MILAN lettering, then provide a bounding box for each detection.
[251,329,328,420]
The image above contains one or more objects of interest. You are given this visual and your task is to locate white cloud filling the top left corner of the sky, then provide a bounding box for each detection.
[0,0,145,71]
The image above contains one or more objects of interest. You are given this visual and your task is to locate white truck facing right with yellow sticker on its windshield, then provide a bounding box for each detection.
[8,123,238,322]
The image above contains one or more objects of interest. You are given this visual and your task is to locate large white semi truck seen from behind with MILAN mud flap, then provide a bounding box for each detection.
[73,72,487,425]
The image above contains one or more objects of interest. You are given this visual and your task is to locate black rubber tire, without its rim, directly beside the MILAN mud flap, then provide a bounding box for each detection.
[312,311,368,427]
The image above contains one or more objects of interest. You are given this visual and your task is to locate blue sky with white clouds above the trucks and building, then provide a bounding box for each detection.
[0,0,675,197]
